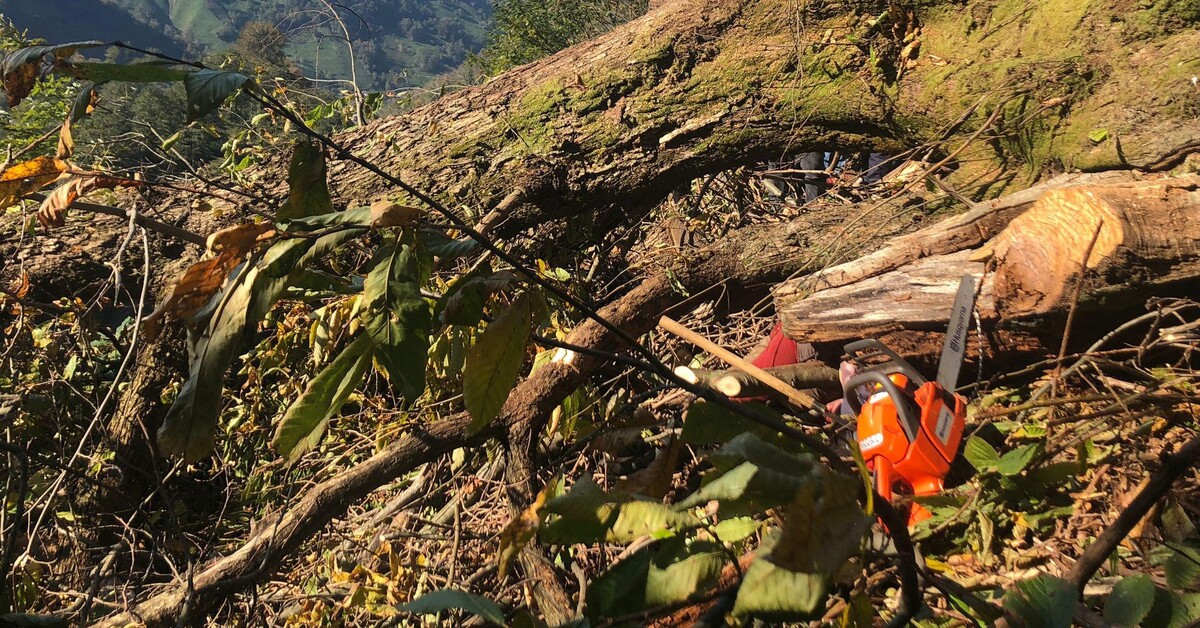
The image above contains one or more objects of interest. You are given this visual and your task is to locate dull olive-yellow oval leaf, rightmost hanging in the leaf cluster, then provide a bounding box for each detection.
[462,294,533,433]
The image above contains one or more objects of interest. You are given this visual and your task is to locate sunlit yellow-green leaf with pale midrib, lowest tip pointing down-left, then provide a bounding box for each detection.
[271,336,371,462]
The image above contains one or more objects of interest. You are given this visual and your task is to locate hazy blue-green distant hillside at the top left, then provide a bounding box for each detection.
[0,0,491,89]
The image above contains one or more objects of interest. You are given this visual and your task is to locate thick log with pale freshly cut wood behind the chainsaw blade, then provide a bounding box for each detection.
[776,177,1200,353]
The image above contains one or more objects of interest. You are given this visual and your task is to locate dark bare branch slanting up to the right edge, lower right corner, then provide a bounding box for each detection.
[1067,437,1200,594]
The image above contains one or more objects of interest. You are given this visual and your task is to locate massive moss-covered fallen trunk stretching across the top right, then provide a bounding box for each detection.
[319,0,1200,240]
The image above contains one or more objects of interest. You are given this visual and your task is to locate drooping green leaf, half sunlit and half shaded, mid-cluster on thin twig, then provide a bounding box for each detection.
[362,231,433,403]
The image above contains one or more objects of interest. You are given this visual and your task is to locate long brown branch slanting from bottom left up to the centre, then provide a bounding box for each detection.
[100,214,825,627]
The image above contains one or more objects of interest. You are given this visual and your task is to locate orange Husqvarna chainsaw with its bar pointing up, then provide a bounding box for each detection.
[842,275,974,526]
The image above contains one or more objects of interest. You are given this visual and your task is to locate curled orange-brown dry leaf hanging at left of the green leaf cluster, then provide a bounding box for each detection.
[145,222,275,337]
